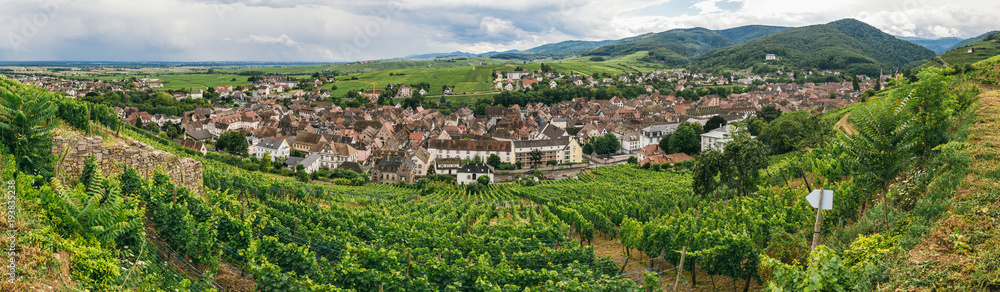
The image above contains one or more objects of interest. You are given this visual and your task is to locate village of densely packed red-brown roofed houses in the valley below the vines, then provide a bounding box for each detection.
[5,70,876,184]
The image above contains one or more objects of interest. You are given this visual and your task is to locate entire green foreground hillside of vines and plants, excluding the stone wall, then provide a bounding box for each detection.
[0,58,1000,291]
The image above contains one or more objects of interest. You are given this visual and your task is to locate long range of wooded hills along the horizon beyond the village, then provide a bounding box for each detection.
[407,19,992,75]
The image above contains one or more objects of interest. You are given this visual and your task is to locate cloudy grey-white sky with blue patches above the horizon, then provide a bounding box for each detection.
[0,0,1000,62]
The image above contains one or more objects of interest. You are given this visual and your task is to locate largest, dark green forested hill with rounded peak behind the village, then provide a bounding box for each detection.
[692,19,935,76]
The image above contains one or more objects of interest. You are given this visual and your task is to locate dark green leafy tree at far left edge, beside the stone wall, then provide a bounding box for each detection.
[0,79,58,178]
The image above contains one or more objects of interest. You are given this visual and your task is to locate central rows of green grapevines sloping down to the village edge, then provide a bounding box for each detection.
[143,157,811,291]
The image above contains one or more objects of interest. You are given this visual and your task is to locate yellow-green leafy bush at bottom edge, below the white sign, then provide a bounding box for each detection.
[761,245,851,291]
